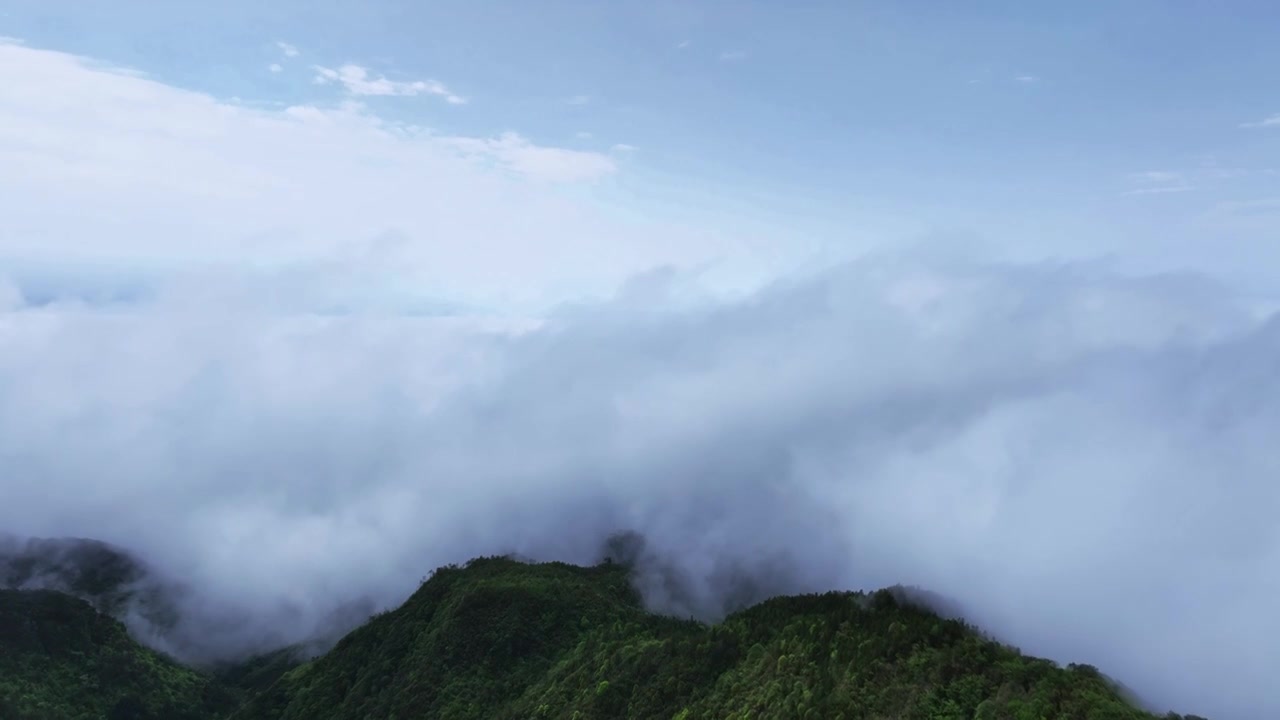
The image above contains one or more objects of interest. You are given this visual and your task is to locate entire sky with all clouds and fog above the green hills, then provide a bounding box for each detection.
[0,0,1280,719]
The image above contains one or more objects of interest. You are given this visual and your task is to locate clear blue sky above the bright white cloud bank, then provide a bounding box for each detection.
[0,0,1280,304]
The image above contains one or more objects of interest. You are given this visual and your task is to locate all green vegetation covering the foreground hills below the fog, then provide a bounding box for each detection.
[0,557,1194,720]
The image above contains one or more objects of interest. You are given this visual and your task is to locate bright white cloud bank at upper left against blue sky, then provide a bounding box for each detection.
[0,45,747,306]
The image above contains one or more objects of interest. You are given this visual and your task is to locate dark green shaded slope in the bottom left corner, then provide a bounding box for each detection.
[0,589,237,720]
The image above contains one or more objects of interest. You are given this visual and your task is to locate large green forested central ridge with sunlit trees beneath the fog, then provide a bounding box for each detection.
[234,559,1208,720]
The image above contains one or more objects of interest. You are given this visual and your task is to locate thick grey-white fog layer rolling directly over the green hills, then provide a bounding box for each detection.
[0,258,1280,717]
